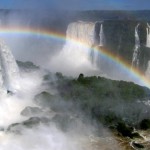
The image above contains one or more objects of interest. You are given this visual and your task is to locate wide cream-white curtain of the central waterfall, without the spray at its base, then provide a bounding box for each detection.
[63,21,95,66]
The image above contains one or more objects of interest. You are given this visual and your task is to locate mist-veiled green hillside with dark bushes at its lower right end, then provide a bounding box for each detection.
[35,73,150,141]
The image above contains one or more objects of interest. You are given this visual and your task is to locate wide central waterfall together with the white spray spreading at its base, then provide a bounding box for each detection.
[50,21,98,76]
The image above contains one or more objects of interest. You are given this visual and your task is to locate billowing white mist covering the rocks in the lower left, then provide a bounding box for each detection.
[0,59,123,150]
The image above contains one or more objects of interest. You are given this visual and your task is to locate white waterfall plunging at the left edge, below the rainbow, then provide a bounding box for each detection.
[0,41,19,93]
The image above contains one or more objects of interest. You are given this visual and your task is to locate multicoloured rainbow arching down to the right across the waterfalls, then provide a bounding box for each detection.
[0,27,150,88]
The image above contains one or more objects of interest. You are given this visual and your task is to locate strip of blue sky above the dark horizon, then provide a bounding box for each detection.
[0,0,150,10]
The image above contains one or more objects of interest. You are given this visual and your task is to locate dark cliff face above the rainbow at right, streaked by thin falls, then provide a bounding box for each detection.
[97,20,150,72]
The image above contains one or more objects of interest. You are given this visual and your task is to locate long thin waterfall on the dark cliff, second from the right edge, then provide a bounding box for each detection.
[132,24,140,67]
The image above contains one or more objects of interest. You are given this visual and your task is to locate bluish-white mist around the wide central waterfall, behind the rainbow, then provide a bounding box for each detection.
[0,10,145,83]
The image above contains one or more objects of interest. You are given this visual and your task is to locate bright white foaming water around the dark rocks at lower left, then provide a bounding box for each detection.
[0,67,120,150]
